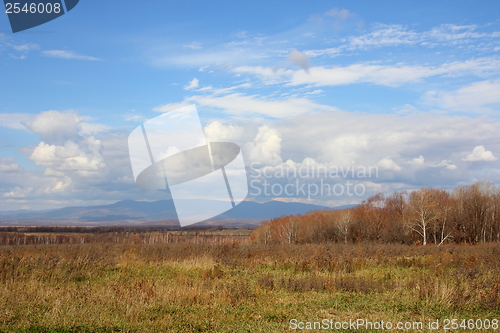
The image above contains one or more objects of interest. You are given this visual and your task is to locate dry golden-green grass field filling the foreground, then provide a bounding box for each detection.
[0,235,500,332]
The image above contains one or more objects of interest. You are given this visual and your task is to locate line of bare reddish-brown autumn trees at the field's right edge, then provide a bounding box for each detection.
[251,182,500,245]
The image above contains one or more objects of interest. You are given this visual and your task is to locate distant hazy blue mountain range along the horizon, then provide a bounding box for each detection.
[0,200,353,228]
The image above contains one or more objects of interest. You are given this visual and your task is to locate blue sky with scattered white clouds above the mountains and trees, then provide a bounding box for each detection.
[0,0,500,210]
